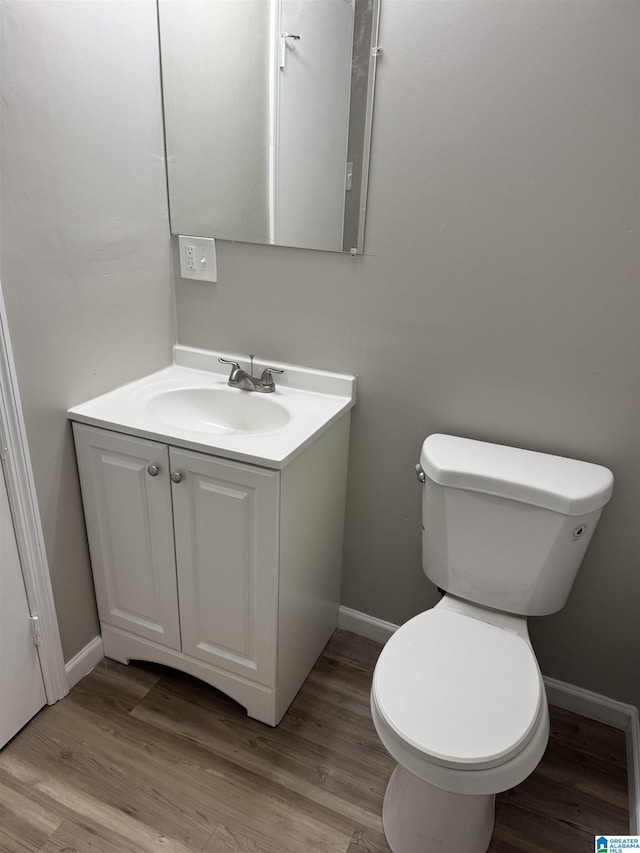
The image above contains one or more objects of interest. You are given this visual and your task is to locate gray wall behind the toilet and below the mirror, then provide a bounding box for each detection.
[177,0,640,704]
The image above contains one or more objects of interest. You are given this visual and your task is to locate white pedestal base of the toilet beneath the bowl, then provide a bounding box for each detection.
[382,764,495,853]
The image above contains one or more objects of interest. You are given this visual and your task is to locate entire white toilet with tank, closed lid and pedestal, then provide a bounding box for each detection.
[371,434,613,853]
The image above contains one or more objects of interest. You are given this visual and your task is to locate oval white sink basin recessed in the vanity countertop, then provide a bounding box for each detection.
[146,387,291,433]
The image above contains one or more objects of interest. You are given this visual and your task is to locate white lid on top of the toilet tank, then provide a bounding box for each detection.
[420,433,613,516]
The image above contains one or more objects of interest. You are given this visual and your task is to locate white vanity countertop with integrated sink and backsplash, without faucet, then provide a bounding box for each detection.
[69,346,356,468]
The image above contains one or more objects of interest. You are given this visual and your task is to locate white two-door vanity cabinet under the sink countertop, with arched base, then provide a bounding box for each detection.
[73,412,349,725]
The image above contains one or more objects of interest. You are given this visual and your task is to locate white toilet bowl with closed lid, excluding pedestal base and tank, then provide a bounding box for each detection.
[371,596,549,794]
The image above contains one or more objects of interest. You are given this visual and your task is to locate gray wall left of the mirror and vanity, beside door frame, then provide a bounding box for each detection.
[0,0,175,660]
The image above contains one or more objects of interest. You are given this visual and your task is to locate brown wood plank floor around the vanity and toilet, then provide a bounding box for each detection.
[0,631,629,853]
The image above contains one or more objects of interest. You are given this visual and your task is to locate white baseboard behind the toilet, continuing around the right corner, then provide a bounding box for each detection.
[338,607,640,835]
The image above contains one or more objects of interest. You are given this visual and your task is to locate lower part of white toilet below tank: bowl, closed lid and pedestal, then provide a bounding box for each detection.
[371,596,549,853]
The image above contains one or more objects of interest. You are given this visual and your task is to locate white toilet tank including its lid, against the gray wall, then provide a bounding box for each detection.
[420,434,613,616]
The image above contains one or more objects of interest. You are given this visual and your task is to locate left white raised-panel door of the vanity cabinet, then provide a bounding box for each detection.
[73,424,180,650]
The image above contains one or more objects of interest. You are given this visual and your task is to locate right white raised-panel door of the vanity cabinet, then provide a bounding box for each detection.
[170,448,279,687]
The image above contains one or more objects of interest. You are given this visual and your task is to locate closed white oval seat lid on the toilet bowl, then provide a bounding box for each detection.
[372,608,542,769]
